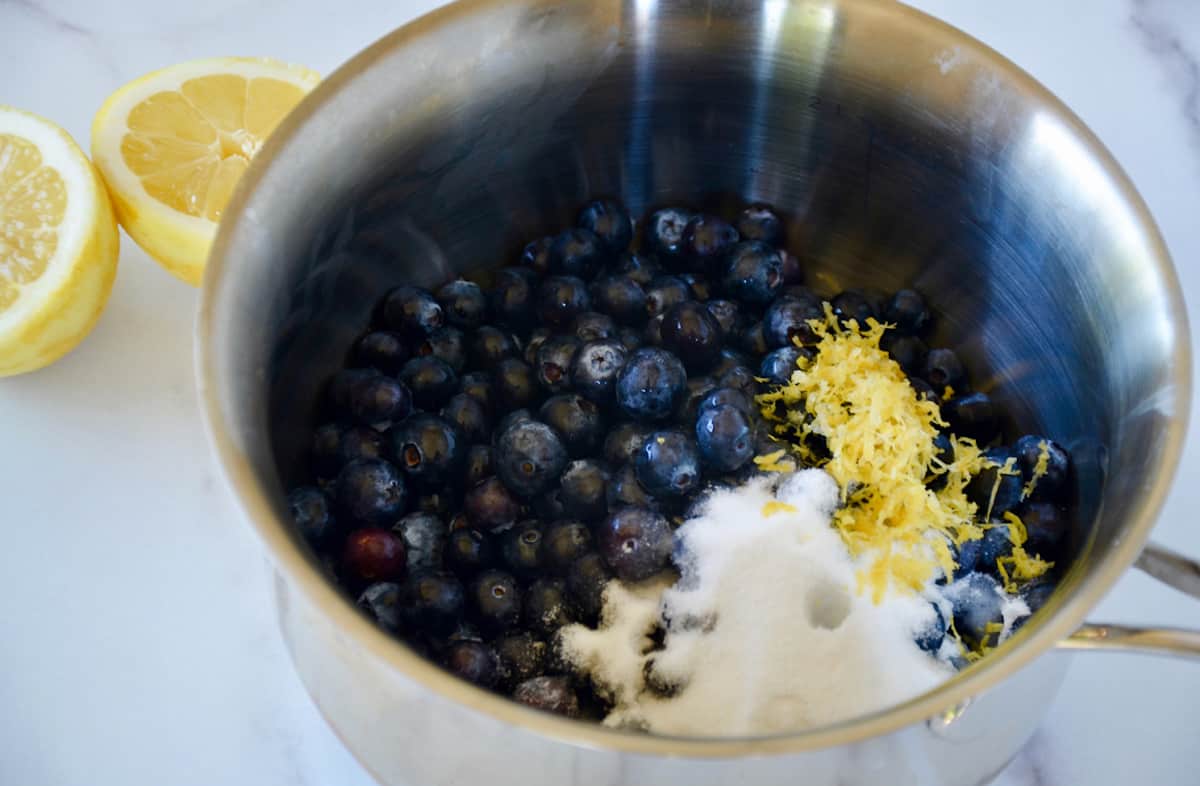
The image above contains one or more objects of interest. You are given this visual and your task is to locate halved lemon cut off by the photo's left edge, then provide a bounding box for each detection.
[0,106,119,377]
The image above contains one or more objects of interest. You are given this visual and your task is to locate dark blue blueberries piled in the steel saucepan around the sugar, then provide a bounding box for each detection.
[289,200,1067,716]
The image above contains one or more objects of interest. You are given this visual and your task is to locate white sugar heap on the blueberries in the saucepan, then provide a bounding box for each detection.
[562,469,954,737]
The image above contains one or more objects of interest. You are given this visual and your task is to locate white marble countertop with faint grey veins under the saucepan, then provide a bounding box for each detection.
[0,0,1200,786]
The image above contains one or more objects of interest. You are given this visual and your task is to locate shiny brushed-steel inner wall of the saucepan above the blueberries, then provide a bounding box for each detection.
[209,0,1181,739]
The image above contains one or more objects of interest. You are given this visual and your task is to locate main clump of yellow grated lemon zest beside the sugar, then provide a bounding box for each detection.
[755,304,989,602]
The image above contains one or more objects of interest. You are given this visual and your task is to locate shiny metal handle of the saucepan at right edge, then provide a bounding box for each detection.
[1058,544,1200,660]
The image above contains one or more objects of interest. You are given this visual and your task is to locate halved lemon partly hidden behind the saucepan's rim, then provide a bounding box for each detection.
[91,58,319,284]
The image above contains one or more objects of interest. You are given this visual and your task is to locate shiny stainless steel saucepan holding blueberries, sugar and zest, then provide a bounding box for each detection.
[197,0,1200,786]
